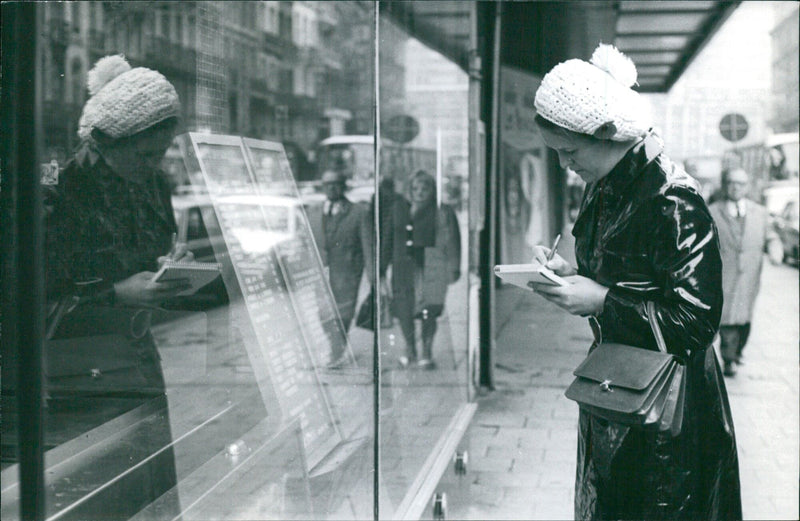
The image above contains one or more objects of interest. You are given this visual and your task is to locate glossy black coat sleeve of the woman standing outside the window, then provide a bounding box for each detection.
[599,187,722,356]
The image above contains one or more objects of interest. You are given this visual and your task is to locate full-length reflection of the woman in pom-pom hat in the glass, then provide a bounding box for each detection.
[46,56,191,519]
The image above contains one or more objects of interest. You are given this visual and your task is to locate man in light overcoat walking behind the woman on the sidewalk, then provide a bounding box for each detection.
[710,168,775,376]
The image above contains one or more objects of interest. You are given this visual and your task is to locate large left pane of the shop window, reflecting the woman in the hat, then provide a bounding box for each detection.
[1,2,378,521]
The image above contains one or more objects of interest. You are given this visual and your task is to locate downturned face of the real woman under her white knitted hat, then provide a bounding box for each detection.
[540,128,619,183]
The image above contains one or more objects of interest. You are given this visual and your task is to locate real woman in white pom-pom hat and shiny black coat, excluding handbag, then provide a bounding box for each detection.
[534,45,742,520]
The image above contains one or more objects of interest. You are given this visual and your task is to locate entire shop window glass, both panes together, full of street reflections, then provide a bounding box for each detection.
[0,1,477,520]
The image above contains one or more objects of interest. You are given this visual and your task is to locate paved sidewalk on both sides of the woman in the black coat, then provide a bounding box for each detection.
[448,258,800,520]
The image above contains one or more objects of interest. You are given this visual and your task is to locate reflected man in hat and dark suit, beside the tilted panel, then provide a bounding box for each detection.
[322,171,369,366]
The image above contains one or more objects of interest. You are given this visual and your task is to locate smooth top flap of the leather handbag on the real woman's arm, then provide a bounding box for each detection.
[573,343,673,391]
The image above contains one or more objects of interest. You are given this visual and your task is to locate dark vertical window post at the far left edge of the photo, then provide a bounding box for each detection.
[2,2,45,521]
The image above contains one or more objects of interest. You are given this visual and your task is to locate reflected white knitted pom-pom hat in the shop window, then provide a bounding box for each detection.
[78,55,180,139]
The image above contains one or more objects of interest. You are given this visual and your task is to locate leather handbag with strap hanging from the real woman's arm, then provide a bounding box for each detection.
[565,302,686,436]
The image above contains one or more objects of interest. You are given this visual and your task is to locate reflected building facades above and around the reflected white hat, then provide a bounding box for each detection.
[42,1,373,164]
